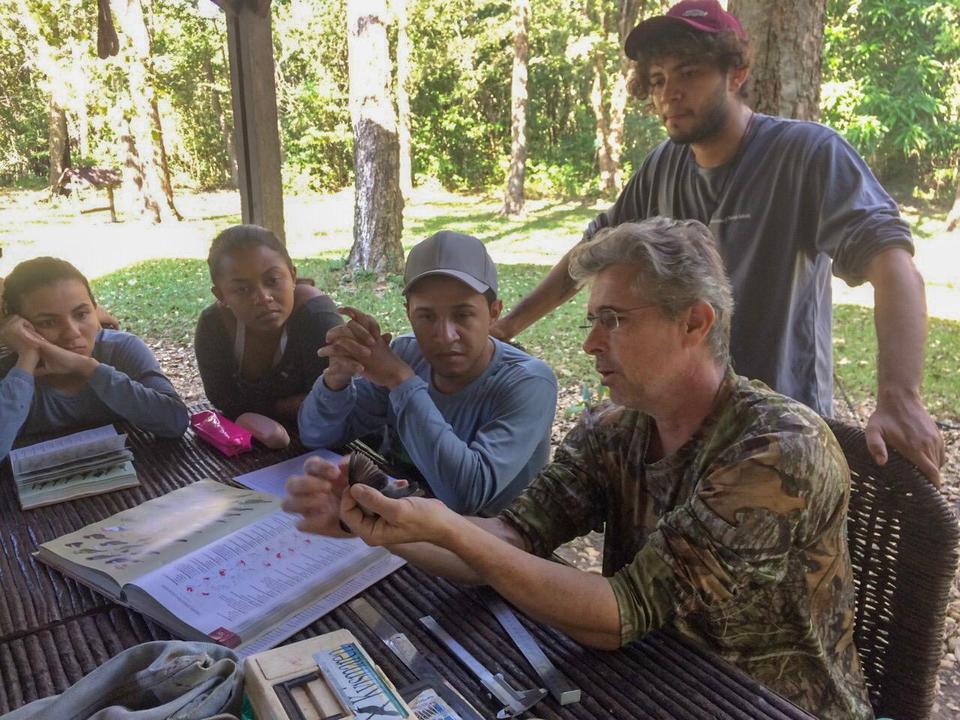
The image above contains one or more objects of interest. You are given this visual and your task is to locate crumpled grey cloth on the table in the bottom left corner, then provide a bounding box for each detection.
[0,640,243,720]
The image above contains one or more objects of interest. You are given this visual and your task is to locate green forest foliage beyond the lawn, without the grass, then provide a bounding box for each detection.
[0,0,960,202]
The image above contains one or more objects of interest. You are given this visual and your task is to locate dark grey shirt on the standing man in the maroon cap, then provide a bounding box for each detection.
[584,114,913,415]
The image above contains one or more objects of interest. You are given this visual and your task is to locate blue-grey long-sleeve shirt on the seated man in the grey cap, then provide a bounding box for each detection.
[299,335,557,515]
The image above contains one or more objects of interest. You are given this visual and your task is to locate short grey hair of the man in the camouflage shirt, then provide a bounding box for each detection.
[570,217,733,365]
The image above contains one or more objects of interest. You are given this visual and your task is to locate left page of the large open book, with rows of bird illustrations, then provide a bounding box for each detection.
[39,480,280,587]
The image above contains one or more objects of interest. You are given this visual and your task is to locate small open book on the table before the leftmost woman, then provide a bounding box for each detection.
[10,425,140,510]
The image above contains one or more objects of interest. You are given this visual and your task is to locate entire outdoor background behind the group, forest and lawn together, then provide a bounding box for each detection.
[0,0,960,414]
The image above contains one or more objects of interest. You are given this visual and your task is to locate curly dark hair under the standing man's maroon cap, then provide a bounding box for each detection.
[629,27,751,100]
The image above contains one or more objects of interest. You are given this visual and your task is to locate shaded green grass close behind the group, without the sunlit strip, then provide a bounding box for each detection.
[93,259,960,420]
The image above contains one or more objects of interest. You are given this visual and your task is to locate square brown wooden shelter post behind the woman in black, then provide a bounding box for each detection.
[214,0,286,242]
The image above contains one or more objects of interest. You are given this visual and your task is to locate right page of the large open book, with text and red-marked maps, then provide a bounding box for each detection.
[128,511,390,648]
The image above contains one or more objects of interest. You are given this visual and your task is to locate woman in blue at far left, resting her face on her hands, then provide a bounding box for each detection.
[0,257,187,459]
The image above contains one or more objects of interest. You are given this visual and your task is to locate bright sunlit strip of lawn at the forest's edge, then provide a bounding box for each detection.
[0,187,604,277]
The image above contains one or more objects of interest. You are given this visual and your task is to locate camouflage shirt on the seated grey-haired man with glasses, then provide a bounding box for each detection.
[501,372,873,718]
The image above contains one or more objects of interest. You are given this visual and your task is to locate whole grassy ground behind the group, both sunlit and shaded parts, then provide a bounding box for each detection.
[0,187,960,421]
